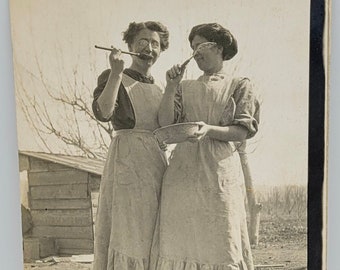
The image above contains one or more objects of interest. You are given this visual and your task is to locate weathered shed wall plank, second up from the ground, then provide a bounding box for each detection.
[32,226,93,240]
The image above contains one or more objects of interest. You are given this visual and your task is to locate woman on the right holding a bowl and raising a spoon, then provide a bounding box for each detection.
[150,23,259,270]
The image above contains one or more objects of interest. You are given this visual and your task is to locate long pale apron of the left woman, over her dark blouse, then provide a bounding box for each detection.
[93,75,166,270]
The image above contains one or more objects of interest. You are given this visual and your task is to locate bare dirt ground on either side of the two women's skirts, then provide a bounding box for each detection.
[24,218,307,270]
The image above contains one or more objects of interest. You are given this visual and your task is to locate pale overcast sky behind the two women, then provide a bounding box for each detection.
[10,0,309,184]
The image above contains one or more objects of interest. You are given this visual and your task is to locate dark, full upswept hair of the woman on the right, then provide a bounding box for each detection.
[189,23,237,60]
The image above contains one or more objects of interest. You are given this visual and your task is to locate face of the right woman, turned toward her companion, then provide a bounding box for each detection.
[191,35,223,73]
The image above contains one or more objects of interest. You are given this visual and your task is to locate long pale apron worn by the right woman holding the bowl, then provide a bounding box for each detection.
[150,77,253,270]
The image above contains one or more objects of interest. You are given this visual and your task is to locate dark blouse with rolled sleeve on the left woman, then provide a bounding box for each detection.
[92,69,154,130]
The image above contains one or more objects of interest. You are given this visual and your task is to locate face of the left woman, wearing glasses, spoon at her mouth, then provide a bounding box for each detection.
[129,28,161,66]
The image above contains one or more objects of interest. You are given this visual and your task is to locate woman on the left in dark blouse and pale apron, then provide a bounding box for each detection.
[92,21,169,270]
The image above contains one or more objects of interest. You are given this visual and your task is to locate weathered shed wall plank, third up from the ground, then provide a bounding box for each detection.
[31,209,93,226]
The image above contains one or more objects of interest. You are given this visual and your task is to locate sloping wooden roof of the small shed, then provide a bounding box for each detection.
[19,151,105,175]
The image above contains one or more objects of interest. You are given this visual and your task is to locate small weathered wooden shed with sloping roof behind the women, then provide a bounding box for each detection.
[19,151,104,259]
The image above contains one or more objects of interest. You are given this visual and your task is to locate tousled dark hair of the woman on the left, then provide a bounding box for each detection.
[123,21,169,51]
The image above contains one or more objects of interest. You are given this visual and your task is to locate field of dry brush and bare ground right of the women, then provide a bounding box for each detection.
[253,185,307,269]
